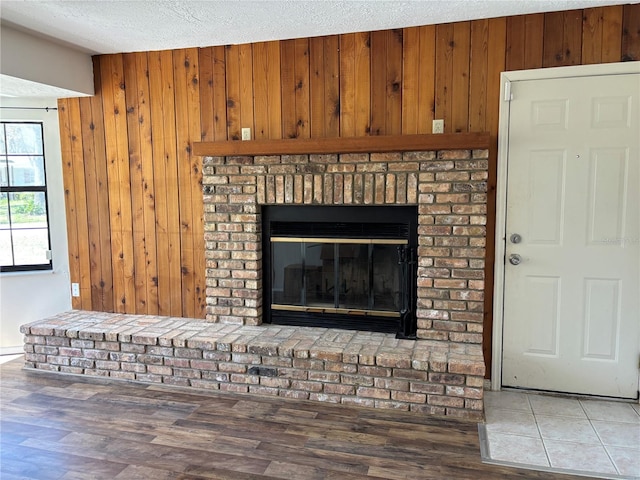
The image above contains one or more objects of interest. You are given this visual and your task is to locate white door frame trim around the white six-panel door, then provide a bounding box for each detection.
[491,62,640,390]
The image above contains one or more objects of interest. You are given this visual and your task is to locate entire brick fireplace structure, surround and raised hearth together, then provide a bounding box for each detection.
[22,146,488,419]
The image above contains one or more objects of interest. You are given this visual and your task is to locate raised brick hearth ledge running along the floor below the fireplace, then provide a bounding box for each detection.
[21,310,484,420]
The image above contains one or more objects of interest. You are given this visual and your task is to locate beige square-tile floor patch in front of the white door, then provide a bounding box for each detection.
[480,391,640,480]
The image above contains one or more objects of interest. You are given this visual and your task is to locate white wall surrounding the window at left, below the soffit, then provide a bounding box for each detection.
[0,98,71,354]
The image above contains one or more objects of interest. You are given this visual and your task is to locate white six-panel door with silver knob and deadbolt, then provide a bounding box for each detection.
[502,74,640,398]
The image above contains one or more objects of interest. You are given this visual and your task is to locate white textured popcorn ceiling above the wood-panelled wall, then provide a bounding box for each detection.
[0,0,638,54]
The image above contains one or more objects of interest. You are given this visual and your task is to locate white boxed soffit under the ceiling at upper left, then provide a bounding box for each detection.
[0,25,94,97]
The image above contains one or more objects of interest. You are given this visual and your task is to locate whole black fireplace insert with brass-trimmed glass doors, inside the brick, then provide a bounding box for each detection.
[263,206,418,338]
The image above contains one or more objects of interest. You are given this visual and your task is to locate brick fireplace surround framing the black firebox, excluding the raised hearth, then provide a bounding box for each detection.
[203,150,488,344]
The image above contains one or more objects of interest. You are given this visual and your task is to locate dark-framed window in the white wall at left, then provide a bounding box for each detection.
[0,122,52,272]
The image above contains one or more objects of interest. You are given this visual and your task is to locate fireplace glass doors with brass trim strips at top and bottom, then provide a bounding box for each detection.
[271,237,408,317]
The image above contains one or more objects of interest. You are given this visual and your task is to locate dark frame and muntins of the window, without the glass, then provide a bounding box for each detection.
[0,120,53,273]
